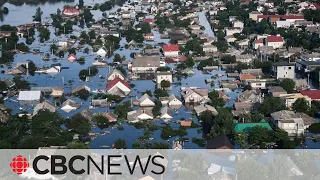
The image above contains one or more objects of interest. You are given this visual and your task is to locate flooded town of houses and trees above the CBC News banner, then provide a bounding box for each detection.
[0,0,320,153]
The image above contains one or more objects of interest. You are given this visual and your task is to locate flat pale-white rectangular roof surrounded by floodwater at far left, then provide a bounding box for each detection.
[18,91,42,106]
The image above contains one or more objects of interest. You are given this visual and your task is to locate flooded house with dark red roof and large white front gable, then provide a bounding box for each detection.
[106,77,131,97]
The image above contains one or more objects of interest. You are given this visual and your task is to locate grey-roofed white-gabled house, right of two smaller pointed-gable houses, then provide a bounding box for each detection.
[181,88,209,103]
